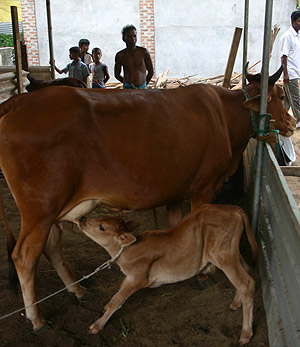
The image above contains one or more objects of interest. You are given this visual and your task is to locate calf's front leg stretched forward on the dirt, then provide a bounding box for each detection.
[89,277,146,334]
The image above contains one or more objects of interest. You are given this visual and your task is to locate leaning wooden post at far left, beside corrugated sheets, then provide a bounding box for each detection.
[10,6,24,94]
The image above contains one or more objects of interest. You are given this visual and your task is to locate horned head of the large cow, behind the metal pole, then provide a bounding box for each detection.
[244,63,296,137]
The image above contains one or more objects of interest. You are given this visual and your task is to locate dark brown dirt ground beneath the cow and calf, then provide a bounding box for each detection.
[0,131,300,347]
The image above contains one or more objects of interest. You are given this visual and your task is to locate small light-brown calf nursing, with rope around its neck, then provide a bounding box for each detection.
[79,204,258,344]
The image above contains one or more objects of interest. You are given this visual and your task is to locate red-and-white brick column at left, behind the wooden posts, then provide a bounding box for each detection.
[21,0,39,66]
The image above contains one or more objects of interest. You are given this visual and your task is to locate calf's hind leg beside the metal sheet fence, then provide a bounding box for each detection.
[219,261,255,345]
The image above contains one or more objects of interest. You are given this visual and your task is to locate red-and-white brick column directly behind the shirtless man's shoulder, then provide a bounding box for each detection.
[140,0,155,73]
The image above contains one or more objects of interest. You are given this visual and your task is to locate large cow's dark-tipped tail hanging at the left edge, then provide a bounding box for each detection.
[0,177,19,293]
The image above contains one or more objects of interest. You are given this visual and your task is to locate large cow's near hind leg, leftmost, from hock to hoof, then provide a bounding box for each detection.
[12,220,50,330]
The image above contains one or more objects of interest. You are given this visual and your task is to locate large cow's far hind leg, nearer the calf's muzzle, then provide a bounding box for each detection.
[44,224,85,298]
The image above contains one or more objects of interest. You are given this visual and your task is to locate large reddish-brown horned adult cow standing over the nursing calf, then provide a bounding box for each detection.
[0,64,296,330]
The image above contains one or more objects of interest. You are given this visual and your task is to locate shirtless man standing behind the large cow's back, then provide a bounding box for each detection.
[115,25,153,89]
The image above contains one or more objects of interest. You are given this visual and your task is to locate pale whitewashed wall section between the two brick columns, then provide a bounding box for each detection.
[35,0,140,77]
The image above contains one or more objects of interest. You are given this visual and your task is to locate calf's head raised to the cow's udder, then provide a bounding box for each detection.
[78,217,138,249]
